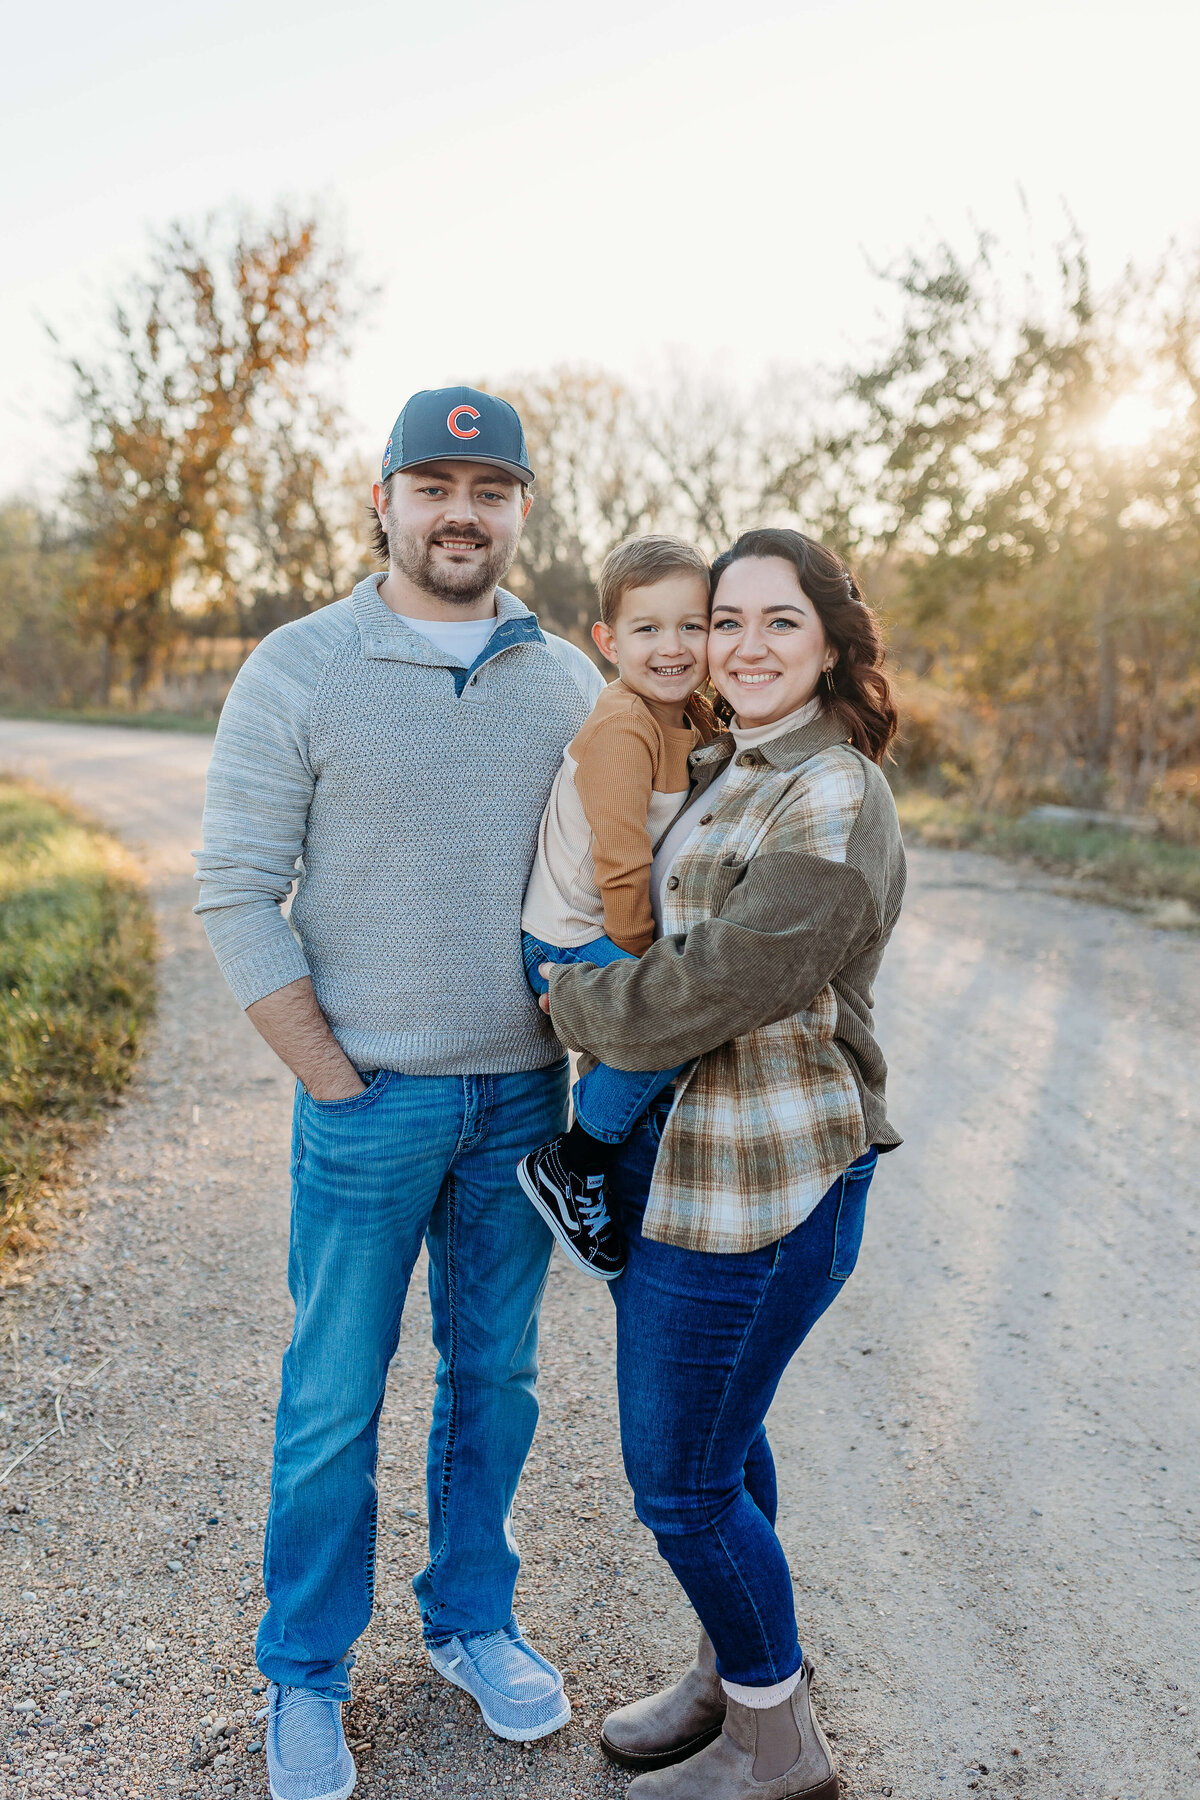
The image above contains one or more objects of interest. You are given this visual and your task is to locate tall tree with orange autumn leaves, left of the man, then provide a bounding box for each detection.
[63,212,363,700]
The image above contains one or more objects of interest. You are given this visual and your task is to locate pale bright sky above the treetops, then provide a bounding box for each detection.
[0,0,1200,493]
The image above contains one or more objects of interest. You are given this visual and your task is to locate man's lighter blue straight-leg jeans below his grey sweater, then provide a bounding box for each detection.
[257,1060,567,1699]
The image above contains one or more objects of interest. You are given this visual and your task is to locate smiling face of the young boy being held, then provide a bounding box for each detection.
[592,569,709,706]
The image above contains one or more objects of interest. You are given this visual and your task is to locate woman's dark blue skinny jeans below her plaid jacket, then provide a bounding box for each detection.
[606,1102,876,1687]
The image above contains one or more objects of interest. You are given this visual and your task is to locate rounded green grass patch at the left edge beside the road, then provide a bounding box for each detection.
[0,779,155,1255]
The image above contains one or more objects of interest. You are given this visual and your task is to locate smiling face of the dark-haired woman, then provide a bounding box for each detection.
[709,556,837,727]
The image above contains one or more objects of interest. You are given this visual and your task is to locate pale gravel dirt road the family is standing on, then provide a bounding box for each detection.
[0,722,1200,1800]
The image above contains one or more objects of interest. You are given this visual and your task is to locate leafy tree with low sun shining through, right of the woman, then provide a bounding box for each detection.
[841,241,1200,801]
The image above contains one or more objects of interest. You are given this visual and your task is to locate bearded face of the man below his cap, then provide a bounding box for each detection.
[372,463,529,607]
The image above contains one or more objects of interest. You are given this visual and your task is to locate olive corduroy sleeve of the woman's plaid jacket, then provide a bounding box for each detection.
[549,851,880,1069]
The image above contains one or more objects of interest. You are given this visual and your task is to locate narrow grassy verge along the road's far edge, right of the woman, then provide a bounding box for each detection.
[896,788,1200,925]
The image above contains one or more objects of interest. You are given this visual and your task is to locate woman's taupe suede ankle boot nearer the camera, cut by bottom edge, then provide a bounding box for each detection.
[630,1669,838,1800]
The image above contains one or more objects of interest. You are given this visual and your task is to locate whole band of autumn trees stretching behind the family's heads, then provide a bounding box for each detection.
[0,214,1200,837]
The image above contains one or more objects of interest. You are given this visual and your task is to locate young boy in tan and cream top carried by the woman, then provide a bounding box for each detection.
[516,536,714,1282]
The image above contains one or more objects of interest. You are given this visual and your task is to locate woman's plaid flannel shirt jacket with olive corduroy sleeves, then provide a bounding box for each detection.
[549,713,905,1253]
